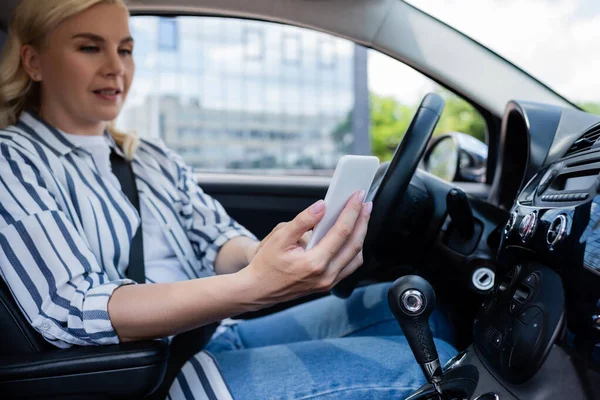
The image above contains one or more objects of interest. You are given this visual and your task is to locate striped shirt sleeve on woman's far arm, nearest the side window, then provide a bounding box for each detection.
[165,142,256,272]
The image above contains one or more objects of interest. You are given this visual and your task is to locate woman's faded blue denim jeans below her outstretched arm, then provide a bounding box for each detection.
[171,283,456,400]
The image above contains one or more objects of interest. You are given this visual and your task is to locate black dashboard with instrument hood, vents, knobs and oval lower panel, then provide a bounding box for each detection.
[466,102,600,397]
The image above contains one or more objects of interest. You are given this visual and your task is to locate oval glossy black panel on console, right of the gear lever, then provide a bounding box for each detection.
[474,263,565,384]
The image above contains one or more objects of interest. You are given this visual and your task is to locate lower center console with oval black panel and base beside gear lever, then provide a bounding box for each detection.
[401,263,589,400]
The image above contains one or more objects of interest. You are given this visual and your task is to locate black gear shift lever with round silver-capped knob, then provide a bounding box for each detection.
[388,275,443,394]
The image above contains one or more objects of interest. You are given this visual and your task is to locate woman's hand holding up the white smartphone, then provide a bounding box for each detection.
[238,192,372,308]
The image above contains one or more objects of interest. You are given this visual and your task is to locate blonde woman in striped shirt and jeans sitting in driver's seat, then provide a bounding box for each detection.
[0,0,454,399]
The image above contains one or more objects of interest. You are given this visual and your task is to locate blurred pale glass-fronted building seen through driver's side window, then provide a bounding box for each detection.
[118,17,370,170]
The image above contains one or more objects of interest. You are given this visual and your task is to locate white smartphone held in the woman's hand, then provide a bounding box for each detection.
[306,155,379,250]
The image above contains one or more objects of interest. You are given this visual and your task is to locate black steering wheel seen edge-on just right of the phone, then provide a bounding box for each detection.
[331,93,444,298]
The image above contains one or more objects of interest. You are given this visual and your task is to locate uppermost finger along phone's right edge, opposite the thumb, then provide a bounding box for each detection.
[314,192,364,262]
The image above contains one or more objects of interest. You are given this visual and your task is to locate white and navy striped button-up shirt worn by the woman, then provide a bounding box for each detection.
[0,112,254,347]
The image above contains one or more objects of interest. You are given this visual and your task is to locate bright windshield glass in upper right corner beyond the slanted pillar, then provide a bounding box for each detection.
[405,0,600,114]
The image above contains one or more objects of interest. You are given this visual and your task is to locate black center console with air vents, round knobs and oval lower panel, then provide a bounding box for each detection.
[398,147,600,400]
